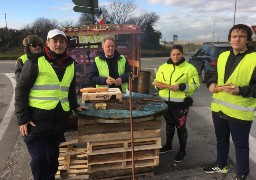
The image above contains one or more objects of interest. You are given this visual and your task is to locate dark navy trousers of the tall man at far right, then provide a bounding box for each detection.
[212,112,252,176]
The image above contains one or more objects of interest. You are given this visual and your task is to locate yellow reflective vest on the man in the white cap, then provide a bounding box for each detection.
[29,57,74,111]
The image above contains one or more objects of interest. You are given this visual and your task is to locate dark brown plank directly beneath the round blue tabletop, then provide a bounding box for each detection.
[78,120,161,135]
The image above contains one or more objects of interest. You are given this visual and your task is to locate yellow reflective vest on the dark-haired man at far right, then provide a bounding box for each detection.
[211,51,256,121]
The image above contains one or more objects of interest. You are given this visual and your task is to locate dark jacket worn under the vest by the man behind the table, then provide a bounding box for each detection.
[89,51,131,88]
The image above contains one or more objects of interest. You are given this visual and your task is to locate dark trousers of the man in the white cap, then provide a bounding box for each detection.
[24,134,63,180]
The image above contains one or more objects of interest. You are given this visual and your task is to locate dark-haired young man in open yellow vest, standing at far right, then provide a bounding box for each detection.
[203,24,256,179]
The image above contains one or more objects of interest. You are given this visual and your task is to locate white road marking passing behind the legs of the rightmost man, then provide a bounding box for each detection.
[191,107,256,163]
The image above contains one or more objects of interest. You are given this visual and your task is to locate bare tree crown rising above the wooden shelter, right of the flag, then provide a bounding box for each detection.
[104,0,137,24]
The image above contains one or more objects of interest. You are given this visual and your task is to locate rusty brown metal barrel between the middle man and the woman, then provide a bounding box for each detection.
[138,71,151,94]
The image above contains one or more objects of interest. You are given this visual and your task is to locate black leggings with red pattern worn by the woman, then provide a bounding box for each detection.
[164,108,188,152]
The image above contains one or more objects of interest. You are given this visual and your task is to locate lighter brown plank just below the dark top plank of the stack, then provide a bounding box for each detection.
[78,129,160,143]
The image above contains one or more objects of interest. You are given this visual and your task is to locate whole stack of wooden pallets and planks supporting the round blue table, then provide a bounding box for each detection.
[78,118,161,179]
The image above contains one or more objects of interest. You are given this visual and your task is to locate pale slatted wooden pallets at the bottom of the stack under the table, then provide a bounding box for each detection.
[87,138,161,173]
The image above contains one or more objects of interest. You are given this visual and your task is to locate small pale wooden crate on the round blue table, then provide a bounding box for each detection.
[82,88,123,103]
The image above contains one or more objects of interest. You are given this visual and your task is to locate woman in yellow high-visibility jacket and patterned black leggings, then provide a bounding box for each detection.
[154,45,200,162]
